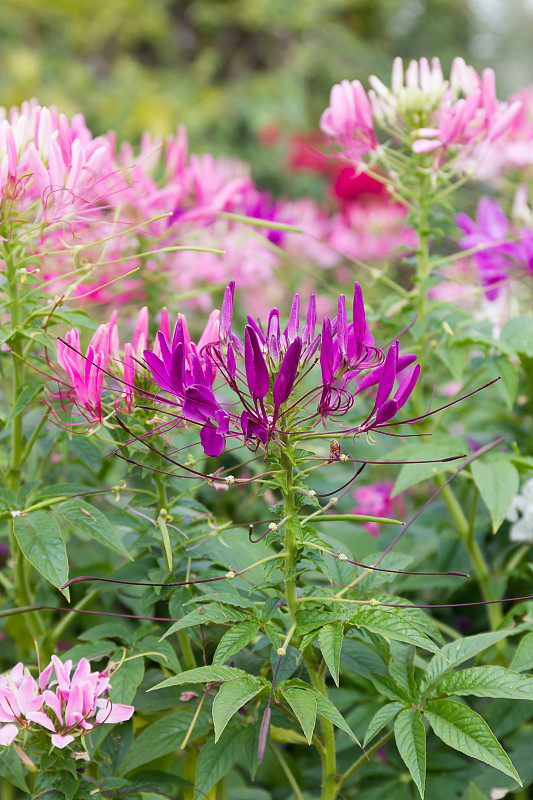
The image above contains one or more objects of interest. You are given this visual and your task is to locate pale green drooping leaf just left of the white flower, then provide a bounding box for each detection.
[471,456,520,533]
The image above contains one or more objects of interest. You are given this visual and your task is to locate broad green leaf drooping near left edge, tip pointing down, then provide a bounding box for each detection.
[14,509,68,589]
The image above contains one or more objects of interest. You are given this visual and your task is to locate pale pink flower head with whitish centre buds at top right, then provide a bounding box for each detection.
[320,58,522,169]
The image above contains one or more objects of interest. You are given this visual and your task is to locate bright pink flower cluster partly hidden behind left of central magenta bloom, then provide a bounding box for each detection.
[52,306,220,426]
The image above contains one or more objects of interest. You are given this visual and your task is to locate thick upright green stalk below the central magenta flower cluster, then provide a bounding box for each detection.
[281,443,337,800]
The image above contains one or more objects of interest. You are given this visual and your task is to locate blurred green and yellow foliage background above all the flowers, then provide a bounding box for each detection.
[0,0,533,193]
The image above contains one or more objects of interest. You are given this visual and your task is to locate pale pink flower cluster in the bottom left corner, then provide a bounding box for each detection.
[0,655,134,749]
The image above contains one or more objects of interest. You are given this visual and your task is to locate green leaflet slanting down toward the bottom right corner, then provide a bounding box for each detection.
[424,700,522,785]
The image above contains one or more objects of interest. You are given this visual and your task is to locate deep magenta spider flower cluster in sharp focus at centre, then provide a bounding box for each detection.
[137,282,420,456]
